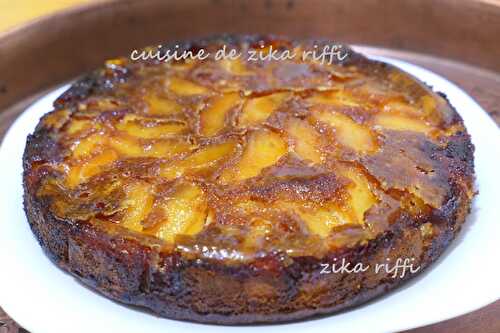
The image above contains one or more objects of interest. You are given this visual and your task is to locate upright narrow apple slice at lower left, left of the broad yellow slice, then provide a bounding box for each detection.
[122,182,154,232]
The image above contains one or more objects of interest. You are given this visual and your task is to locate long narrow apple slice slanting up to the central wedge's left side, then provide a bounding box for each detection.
[160,140,237,179]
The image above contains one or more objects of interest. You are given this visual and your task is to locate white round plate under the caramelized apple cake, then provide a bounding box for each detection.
[0,58,500,333]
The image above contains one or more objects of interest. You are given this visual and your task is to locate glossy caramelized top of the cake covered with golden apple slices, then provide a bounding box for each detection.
[27,37,472,259]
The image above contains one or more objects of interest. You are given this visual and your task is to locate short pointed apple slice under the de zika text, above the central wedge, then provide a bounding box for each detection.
[239,92,290,127]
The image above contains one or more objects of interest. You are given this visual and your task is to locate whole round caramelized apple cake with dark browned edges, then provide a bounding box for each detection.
[23,36,474,324]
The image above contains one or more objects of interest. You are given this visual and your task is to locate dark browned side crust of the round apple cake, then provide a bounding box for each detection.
[23,37,474,324]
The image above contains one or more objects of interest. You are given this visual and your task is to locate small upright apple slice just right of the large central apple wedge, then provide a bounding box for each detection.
[286,118,322,163]
